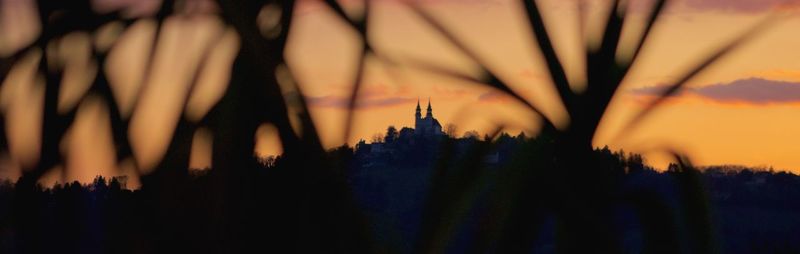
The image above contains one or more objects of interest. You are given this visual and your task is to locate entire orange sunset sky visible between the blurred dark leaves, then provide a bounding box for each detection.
[0,0,800,185]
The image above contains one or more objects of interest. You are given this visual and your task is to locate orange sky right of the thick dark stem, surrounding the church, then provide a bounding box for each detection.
[287,0,800,172]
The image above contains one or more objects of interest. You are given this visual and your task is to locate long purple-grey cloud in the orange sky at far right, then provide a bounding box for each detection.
[631,78,800,105]
